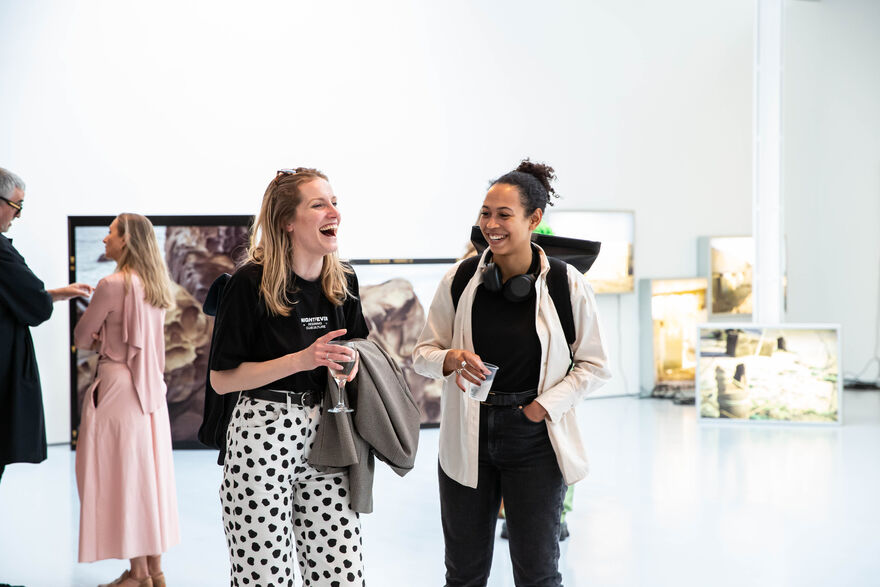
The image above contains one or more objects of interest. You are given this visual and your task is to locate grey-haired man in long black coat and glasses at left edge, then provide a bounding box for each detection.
[0,167,93,484]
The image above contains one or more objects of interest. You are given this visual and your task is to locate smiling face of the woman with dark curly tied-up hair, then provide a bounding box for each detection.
[480,183,543,257]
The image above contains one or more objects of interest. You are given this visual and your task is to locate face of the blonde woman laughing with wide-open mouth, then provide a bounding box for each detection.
[285,178,342,259]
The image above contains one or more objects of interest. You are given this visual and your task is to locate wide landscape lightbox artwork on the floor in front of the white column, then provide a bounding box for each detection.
[697,323,842,424]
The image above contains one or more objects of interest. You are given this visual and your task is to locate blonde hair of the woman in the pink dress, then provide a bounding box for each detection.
[116,213,174,310]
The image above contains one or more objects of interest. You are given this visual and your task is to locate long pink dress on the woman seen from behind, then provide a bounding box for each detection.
[74,272,180,562]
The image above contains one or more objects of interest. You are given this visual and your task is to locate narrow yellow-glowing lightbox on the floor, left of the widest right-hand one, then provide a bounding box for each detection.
[639,278,707,403]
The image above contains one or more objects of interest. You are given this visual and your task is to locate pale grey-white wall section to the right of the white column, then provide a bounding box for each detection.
[783,0,880,380]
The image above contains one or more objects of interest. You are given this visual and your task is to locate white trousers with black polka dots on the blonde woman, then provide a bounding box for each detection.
[220,396,364,587]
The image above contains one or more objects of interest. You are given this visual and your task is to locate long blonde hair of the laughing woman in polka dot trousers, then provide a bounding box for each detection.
[248,167,354,316]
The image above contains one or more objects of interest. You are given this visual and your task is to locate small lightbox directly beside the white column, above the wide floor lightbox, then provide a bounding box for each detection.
[697,236,755,320]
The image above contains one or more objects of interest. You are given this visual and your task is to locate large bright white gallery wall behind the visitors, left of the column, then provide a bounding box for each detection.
[0,0,756,442]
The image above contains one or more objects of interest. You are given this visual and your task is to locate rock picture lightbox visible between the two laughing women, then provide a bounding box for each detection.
[350,259,456,427]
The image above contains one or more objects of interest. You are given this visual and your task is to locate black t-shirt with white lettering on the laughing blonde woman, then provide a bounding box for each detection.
[211,264,369,392]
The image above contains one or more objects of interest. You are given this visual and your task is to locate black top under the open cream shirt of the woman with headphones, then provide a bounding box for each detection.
[471,249,541,393]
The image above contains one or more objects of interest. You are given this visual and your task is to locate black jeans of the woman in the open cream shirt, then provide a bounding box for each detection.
[438,405,566,587]
